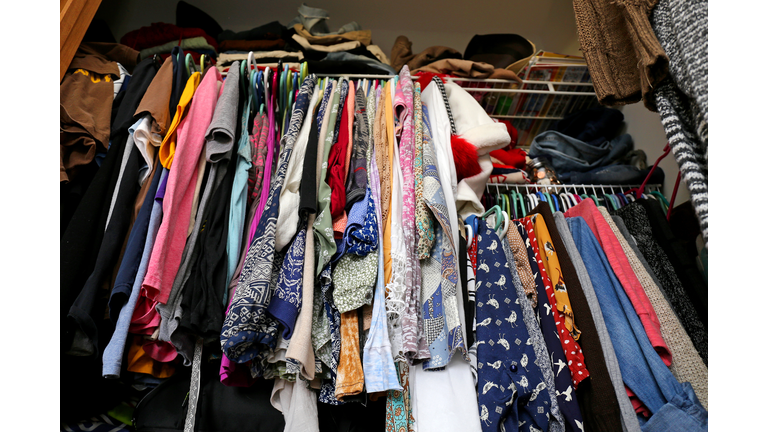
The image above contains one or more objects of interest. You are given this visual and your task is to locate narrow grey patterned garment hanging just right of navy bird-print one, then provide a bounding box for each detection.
[500,236,565,432]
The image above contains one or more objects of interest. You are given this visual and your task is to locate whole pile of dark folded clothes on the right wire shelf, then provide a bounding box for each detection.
[529,105,664,185]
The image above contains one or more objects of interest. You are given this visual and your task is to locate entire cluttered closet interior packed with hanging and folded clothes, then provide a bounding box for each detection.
[60,0,708,432]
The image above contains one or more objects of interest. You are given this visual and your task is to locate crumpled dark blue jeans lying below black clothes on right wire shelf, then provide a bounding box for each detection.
[528,131,632,174]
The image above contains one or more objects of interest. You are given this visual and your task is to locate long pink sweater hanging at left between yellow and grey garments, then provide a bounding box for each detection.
[141,68,222,304]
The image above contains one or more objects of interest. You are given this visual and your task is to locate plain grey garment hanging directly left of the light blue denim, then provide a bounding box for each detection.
[555,212,640,432]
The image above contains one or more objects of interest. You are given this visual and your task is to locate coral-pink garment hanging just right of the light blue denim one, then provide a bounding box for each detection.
[565,199,672,366]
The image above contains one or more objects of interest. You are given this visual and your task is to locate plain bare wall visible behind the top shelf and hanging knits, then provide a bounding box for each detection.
[96,0,689,203]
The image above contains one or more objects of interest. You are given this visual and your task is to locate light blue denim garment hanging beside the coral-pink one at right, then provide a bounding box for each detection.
[568,217,707,432]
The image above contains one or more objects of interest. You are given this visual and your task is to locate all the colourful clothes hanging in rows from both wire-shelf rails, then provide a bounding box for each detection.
[62,55,708,432]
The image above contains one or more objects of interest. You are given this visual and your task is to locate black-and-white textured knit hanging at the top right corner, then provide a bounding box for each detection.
[650,0,709,245]
